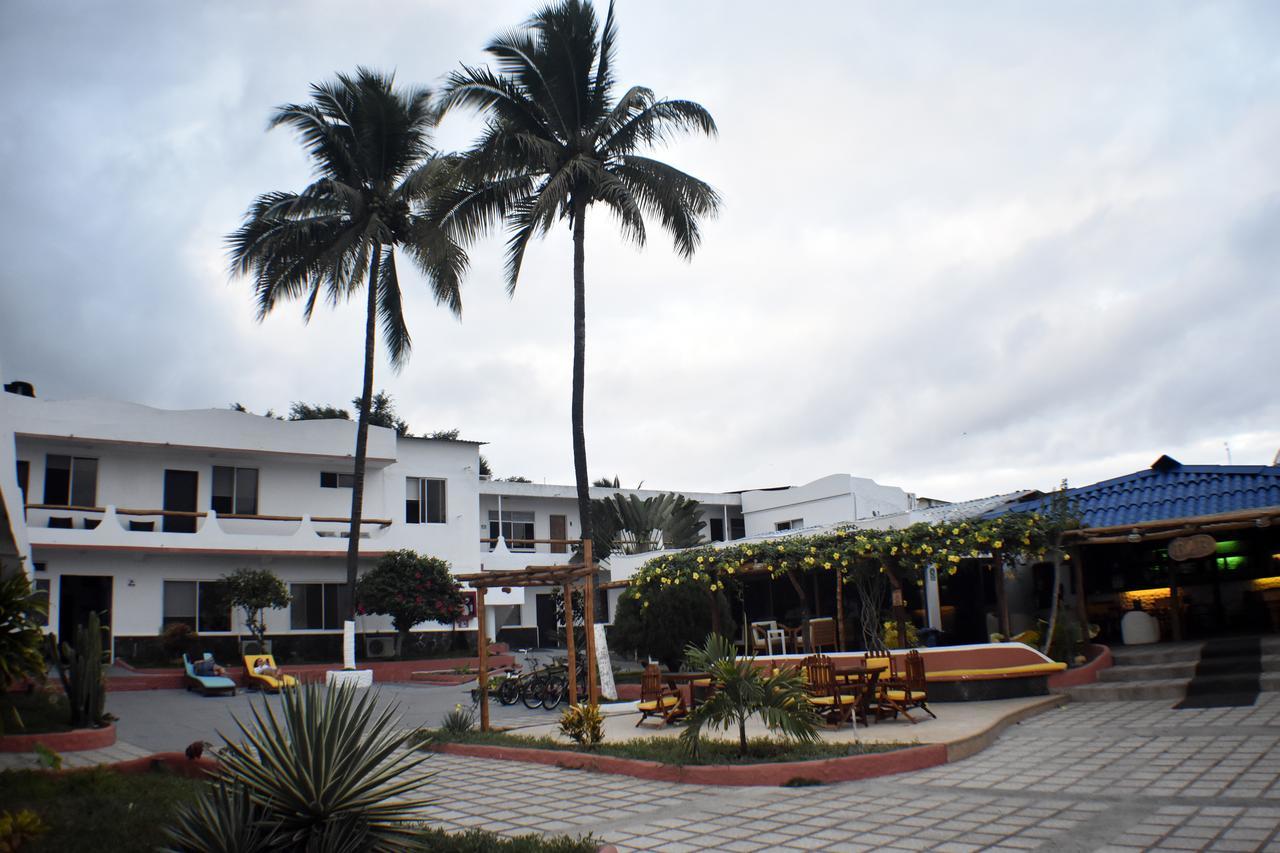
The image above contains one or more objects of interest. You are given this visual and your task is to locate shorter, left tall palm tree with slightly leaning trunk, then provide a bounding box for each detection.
[228,68,467,613]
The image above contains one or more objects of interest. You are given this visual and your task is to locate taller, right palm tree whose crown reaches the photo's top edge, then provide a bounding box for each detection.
[439,0,719,539]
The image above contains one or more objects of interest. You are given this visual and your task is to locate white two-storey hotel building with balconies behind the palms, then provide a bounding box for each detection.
[0,387,936,653]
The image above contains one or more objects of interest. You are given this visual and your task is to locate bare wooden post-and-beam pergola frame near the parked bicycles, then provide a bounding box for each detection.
[457,539,600,731]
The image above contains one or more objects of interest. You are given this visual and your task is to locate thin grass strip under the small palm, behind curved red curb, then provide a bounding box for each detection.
[417,729,919,765]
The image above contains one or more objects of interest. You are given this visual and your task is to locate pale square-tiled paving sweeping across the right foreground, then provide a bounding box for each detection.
[414,693,1280,853]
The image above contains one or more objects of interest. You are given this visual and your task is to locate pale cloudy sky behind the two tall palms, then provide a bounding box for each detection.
[0,0,1280,500]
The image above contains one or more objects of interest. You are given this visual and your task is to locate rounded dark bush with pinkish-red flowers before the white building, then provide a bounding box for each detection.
[356,549,467,654]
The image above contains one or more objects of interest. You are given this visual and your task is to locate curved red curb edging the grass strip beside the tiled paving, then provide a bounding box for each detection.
[429,743,947,788]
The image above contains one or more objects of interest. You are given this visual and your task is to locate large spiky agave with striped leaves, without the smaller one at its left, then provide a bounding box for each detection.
[209,684,431,850]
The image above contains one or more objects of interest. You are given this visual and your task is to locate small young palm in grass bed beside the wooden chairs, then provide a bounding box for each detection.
[680,634,822,758]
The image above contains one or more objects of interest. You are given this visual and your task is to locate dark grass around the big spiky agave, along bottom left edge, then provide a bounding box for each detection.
[0,767,598,853]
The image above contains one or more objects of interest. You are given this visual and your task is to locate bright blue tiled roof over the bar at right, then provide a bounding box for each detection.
[987,456,1280,528]
